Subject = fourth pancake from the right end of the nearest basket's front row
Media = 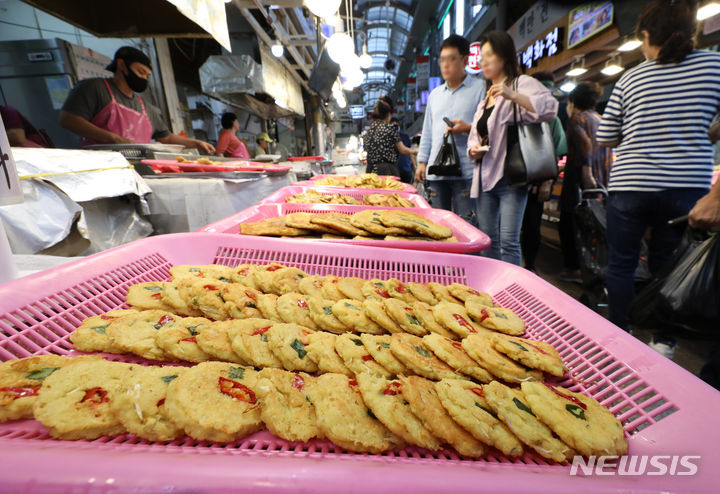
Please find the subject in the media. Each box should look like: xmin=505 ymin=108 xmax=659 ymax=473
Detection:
xmin=399 ymin=376 xmax=485 ymax=458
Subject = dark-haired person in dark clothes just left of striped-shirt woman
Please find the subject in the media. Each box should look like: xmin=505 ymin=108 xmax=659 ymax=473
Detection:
xmin=559 ymin=82 xmax=612 ymax=282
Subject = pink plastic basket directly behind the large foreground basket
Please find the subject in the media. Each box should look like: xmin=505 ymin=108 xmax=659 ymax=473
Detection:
xmin=197 ymin=203 xmax=491 ymax=253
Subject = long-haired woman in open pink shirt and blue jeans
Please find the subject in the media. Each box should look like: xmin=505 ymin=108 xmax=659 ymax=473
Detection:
xmin=468 ymin=31 xmax=558 ymax=265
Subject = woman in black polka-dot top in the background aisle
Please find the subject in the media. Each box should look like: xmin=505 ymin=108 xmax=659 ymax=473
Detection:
xmin=363 ymin=95 xmax=417 ymax=176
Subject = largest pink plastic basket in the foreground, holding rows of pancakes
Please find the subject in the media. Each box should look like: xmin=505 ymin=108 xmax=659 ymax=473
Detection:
xmin=0 ymin=234 xmax=720 ymax=494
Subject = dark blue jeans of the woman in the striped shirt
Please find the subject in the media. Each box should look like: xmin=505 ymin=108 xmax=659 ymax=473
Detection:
xmin=605 ymin=189 xmax=707 ymax=331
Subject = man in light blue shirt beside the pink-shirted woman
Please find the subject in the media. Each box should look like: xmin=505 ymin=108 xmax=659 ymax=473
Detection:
xmin=415 ymin=34 xmax=485 ymax=224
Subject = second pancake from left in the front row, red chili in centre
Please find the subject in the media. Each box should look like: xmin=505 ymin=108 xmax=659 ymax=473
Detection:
xmin=33 ymin=359 xmax=142 ymax=440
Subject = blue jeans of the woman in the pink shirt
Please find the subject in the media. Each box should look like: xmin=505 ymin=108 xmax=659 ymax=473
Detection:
xmin=477 ymin=178 xmax=528 ymax=266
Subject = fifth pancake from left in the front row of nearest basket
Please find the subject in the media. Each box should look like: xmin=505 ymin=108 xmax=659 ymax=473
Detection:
xmin=255 ymin=369 xmax=320 ymax=442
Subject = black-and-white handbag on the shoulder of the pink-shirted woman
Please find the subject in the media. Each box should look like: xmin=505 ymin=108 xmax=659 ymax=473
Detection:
xmin=505 ymin=80 xmax=558 ymax=187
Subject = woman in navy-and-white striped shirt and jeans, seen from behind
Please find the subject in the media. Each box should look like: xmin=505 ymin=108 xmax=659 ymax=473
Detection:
xmin=597 ymin=0 xmax=720 ymax=330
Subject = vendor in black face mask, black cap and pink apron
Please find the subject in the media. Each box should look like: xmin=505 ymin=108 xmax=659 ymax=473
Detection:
xmin=60 ymin=46 xmax=215 ymax=153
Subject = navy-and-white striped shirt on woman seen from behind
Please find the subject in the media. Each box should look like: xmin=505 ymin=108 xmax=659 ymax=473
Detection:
xmin=597 ymin=50 xmax=720 ymax=191
